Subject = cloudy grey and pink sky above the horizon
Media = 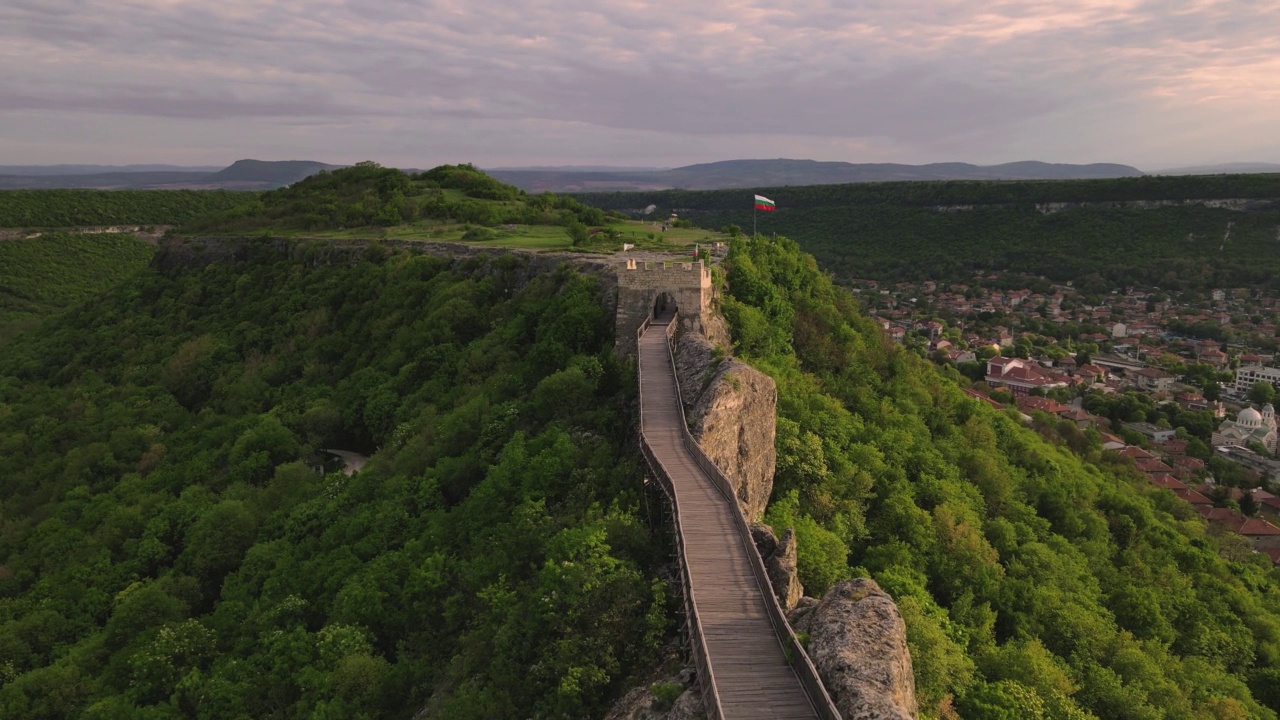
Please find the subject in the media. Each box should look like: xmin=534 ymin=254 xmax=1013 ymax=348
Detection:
xmin=0 ymin=0 xmax=1280 ymax=170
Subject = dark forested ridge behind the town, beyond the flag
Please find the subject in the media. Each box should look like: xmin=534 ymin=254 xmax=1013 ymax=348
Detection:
xmin=576 ymin=174 xmax=1280 ymax=290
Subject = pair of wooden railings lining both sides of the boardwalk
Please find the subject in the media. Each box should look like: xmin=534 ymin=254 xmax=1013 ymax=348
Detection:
xmin=636 ymin=314 xmax=842 ymax=720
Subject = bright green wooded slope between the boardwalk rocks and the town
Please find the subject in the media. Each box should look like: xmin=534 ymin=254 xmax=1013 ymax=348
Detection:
xmin=723 ymin=233 xmax=1280 ymax=720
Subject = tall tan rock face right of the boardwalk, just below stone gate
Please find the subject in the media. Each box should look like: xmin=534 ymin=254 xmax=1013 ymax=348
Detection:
xmin=676 ymin=320 xmax=778 ymax=521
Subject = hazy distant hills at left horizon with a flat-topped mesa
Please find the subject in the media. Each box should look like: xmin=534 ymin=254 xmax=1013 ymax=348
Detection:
xmin=0 ymin=160 xmax=342 ymax=190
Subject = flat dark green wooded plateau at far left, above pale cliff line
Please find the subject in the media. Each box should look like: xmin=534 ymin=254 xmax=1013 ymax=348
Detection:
xmin=0 ymin=190 xmax=256 ymax=228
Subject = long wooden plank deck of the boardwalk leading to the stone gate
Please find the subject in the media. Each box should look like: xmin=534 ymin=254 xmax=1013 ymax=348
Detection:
xmin=639 ymin=320 xmax=818 ymax=720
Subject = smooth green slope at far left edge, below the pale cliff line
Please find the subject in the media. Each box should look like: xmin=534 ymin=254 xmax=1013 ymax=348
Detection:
xmin=0 ymin=233 xmax=155 ymax=345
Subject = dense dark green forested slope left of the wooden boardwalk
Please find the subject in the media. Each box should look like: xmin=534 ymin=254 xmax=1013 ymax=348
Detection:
xmin=0 ymin=242 xmax=671 ymax=720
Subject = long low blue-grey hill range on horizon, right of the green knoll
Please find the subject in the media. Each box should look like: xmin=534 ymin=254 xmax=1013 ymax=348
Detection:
xmin=489 ymin=159 xmax=1143 ymax=192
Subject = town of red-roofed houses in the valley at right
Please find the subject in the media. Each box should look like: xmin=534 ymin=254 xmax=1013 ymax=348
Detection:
xmin=851 ymin=273 xmax=1280 ymax=565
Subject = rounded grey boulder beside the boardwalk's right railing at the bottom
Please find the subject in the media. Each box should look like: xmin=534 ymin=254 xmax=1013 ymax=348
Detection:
xmin=791 ymin=579 xmax=919 ymax=720
